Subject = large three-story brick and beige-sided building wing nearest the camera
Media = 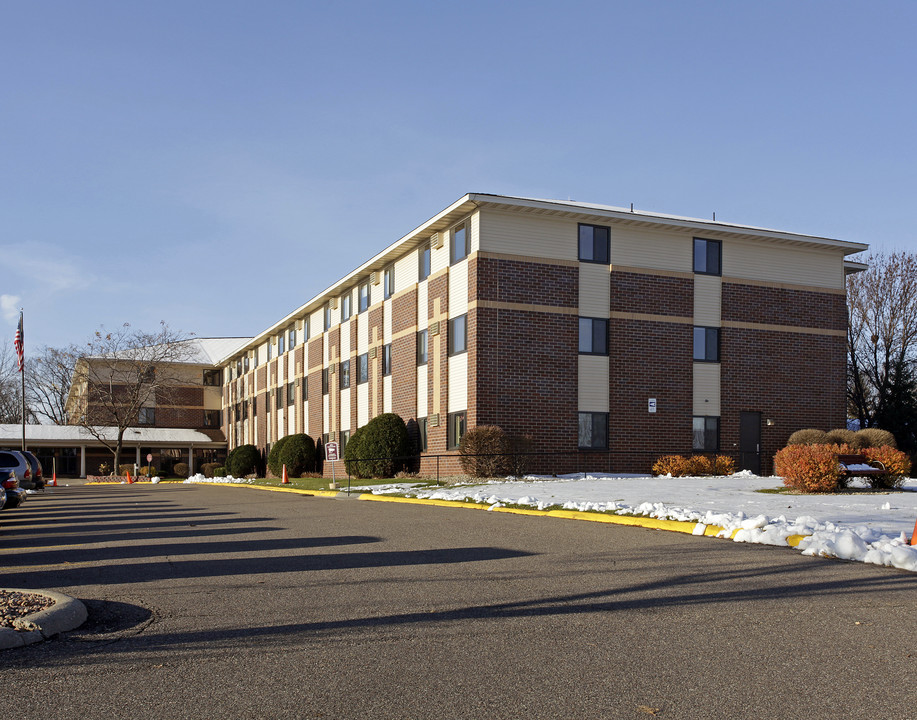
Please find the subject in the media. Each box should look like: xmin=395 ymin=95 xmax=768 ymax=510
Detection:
xmin=222 ymin=194 xmax=867 ymax=472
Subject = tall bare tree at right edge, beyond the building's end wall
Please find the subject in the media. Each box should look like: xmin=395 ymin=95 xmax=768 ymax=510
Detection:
xmin=847 ymin=252 xmax=917 ymax=449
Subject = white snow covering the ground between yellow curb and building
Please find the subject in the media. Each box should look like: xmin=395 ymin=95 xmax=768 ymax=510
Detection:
xmin=364 ymin=471 xmax=917 ymax=572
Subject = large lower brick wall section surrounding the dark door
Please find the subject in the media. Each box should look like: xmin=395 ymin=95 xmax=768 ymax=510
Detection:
xmin=720 ymin=328 xmax=846 ymax=473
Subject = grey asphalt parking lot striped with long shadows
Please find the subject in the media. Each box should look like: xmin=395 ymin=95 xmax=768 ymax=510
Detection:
xmin=0 ymin=484 xmax=917 ymax=720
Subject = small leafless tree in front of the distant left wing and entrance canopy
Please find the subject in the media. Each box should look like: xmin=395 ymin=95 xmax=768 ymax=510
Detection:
xmin=67 ymin=323 xmax=192 ymax=471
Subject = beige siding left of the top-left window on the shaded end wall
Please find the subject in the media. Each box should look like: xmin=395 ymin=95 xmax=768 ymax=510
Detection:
xmin=479 ymin=210 xmax=579 ymax=261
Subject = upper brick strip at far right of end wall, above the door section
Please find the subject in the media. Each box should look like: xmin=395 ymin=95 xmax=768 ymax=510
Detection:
xmin=722 ymin=282 xmax=847 ymax=332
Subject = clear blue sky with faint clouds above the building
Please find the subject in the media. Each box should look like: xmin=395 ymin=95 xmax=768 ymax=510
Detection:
xmin=0 ymin=0 xmax=917 ymax=351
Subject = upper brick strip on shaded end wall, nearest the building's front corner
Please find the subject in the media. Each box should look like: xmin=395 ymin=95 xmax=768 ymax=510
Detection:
xmin=476 ymin=258 xmax=579 ymax=307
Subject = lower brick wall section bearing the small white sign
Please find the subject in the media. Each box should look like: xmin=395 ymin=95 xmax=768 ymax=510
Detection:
xmin=608 ymin=319 xmax=694 ymax=472
